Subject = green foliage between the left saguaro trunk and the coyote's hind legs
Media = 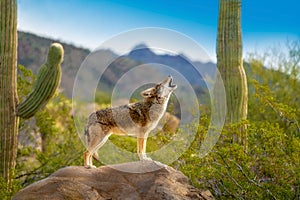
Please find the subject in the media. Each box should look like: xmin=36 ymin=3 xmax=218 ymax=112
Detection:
xmin=8 ymin=65 xmax=84 ymax=195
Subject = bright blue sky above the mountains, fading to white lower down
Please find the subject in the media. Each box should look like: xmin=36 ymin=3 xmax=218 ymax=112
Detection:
xmin=18 ymin=0 xmax=300 ymax=60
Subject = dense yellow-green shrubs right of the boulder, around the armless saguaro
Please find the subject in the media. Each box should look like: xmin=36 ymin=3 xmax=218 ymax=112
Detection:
xmin=173 ymin=42 xmax=300 ymax=199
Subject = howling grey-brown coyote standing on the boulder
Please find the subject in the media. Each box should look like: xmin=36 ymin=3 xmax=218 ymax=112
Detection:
xmin=84 ymin=76 xmax=177 ymax=167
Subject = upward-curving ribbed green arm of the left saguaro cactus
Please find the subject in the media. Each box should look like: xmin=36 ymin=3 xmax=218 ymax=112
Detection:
xmin=18 ymin=43 xmax=64 ymax=119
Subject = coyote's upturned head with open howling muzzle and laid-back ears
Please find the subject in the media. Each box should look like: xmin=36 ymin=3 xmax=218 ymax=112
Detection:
xmin=141 ymin=76 xmax=177 ymax=103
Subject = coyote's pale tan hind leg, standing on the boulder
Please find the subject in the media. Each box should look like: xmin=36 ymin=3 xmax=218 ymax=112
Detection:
xmin=84 ymin=124 xmax=110 ymax=168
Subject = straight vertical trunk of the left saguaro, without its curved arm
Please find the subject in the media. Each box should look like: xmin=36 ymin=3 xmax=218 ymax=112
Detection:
xmin=0 ymin=0 xmax=18 ymax=183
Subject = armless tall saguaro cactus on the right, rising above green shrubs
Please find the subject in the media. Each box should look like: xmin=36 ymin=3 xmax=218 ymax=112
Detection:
xmin=217 ymin=0 xmax=248 ymax=140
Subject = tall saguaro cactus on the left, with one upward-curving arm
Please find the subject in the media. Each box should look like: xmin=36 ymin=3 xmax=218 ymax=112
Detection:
xmin=0 ymin=0 xmax=64 ymax=189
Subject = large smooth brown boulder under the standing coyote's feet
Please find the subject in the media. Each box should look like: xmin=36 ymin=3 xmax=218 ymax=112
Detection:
xmin=13 ymin=161 xmax=214 ymax=200
